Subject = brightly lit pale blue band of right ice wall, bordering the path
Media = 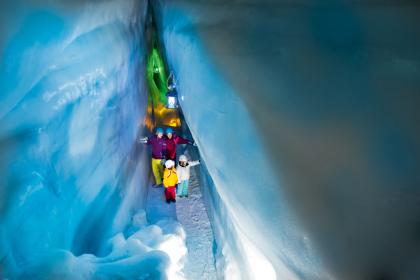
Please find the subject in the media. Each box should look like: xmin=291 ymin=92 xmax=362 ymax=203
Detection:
xmin=155 ymin=1 xmax=322 ymax=279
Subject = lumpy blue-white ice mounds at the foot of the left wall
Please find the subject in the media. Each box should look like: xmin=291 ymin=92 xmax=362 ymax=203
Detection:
xmin=17 ymin=212 xmax=187 ymax=280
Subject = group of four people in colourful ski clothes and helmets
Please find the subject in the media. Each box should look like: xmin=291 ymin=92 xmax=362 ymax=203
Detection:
xmin=140 ymin=127 xmax=200 ymax=203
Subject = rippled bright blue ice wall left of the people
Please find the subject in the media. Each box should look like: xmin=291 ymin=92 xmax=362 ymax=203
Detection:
xmin=0 ymin=0 xmax=149 ymax=275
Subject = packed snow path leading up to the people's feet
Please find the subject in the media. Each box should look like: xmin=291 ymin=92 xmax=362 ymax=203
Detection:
xmin=146 ymin=159 xmax=217 ymax=280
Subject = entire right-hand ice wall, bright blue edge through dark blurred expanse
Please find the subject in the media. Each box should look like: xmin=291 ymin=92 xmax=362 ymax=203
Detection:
xmin=155 ymin=0 xmax=420 ymax=279
